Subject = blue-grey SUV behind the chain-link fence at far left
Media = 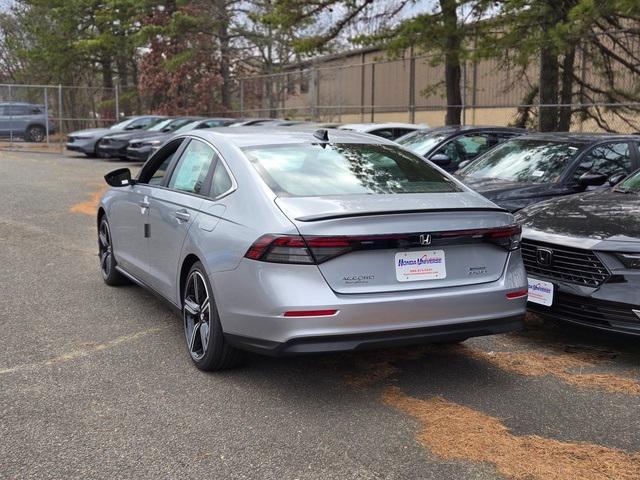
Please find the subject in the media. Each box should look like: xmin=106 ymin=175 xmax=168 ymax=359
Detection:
xmin=0 ymin=102 xmax=56 ymax=142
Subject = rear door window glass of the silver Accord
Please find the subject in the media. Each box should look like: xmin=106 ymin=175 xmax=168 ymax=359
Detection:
xmin=169 ymin=140 xmax=215 ymax=194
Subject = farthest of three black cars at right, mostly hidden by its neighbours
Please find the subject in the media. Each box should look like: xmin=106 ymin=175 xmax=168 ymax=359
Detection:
xmin=396 ymin=126 xmax=527 ymax=172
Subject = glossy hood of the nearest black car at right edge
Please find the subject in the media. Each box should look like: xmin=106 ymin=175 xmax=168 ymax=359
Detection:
xmin=517 ymin=189 xmax=640 ymax=242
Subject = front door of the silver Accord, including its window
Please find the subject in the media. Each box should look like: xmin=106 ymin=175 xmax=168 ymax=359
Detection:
xmin=108 ymin=138 xmax=184 ymax=285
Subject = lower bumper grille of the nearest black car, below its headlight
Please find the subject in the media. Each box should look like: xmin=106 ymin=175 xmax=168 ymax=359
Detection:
xmin=528 ymin=292 xmax=640 ymax=329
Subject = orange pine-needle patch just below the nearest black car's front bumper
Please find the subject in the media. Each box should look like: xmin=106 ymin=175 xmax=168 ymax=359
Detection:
xmin=460 ymin=346 xmax=640 ymax=395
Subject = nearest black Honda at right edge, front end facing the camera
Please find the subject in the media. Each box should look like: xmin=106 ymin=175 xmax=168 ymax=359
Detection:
xmin=516 ymin=170 xmax=640 ymax=336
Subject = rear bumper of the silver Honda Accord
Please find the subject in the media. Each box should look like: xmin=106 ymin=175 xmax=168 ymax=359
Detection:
xmin=210 ymin=254 xmax=527 ymax=354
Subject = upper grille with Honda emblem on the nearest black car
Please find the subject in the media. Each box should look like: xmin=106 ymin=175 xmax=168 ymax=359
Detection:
xmin=522 ymin=240 xmax=609 ymax=287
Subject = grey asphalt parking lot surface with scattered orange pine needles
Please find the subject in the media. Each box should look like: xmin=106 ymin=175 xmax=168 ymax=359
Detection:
xmin=0 ymin=151 xmax=640 ymax=480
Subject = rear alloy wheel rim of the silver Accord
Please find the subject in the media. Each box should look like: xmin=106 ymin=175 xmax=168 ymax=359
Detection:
xmin=183 ymin=270 xmax=211 ymax=361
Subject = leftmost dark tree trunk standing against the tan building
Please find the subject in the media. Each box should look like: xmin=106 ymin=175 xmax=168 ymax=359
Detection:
xmin=440 ymin=0 xmax=462 ymax=125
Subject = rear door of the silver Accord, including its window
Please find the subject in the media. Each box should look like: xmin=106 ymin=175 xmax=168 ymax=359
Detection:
xmin=149 ymin=138 xmax=217 ymax=300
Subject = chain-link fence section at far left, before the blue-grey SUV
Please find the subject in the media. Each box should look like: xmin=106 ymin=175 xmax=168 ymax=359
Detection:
xmin=0 ymin=84 xmax=120 ymax=151
